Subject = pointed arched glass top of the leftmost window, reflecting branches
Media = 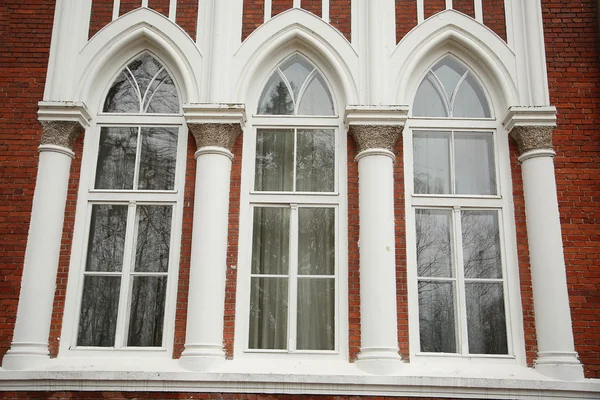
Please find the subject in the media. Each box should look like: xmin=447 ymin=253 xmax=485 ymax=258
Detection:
xmin=102 ymin=52 xmax=179 ymax=114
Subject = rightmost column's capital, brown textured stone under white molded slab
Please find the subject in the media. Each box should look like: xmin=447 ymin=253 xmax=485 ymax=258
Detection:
xmin=503 ymin=106 xmax=556 ymax=155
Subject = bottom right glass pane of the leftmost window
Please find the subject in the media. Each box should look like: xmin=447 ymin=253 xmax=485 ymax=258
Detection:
xmin=127 ymin=276 xmax=167 ymax=347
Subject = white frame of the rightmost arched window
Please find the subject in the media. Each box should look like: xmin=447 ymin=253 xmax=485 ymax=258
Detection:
xmin=403 ymin=54 xmax=526 ymax=365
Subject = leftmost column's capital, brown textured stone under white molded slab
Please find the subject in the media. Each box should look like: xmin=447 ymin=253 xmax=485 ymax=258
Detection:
xmin=38 ymin=101 xmax=91 ymax=150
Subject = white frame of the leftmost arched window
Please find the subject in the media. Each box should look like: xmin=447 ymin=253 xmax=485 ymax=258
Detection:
xmin=59 ymin=50 xmax=188 ymax=359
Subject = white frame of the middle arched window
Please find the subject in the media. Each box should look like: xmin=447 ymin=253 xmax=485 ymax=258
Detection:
xmin=234 ymin=52 xmax=348 ymax=361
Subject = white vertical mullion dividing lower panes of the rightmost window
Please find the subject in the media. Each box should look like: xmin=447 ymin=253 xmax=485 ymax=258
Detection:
xmin=453 ymin=206 xmax=469 ymax=354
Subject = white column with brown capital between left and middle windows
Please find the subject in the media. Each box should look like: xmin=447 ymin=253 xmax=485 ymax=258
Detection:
xmin=180 ymin=123 xmax=241 ymax=371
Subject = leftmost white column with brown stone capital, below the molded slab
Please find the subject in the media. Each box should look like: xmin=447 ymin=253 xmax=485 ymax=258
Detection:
xmin=2 ymin=121 xmax=82 ymax=369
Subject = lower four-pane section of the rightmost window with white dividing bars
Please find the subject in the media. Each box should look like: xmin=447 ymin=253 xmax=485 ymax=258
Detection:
xmin=416 ymin=207 xmax=510 ymax=355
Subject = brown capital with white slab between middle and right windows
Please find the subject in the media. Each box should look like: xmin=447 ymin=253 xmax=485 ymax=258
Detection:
xmin=345 ymin=105 xmax=408 ymax=153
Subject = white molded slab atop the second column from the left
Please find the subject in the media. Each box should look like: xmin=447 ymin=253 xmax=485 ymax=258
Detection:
xmin=183 ymin=103 xmax=246 ymax=128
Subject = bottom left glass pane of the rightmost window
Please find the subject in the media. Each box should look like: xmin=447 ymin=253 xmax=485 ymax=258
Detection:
xmin=419 ymin=282 xmax=457 ymax=353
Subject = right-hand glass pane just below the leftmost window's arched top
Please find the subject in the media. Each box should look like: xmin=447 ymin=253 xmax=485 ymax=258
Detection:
xmin=138 ymin=127 xmax=178 ymax=190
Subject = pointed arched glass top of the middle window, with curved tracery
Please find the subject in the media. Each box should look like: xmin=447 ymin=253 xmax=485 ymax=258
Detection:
xmin=258 ymin=55 xmax=335 ymax=115
